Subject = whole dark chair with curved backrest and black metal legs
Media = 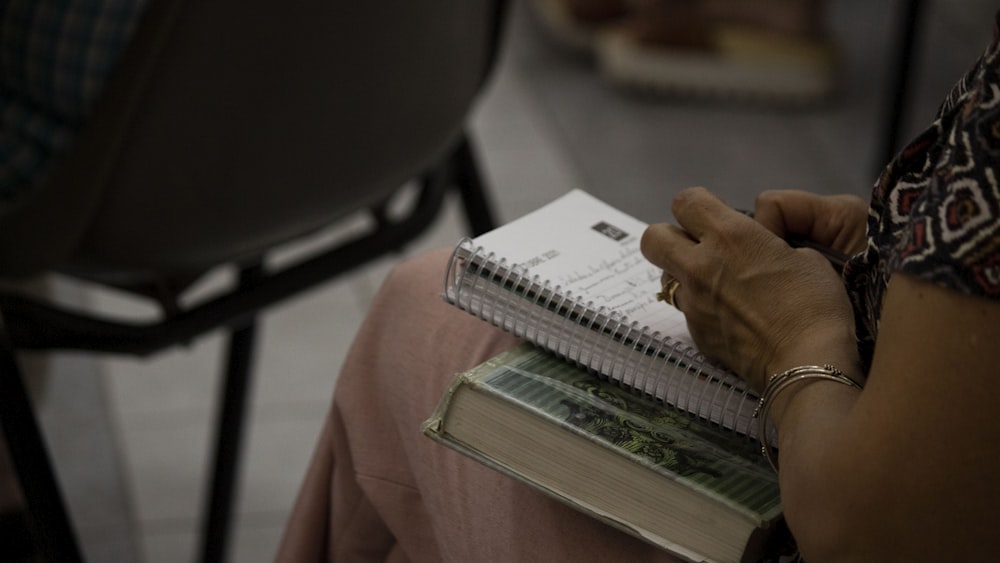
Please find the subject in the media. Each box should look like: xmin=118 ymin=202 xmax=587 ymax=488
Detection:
xmin=0 ymin=0 xmax=506 ymax=562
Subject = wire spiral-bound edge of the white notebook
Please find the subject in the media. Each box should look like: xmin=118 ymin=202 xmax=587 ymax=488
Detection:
xmin=444 ymin=239 xmax=757 ymax=437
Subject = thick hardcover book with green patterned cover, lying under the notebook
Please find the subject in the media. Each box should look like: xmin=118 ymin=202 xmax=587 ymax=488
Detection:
xmin=424 ymin=344 xmax=781 ymax=561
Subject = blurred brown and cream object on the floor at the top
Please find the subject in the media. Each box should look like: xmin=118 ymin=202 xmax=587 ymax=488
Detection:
xmin=534 ymin=0 xmax=838 ymax=104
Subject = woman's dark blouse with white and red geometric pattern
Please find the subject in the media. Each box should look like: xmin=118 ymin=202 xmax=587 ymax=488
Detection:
xmin=844 ymin=14 xmax=1000 ymax=365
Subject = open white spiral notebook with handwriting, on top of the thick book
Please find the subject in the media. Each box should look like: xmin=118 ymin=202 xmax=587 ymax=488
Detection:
xmin=444 ymin=190 xmax=758 ymax=437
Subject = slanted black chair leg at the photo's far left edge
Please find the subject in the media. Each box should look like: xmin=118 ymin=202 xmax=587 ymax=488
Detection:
xmin=0 ymin=330 xmax=83 ymax=563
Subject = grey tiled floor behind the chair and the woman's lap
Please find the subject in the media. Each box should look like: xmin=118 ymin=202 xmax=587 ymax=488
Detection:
xmin=27 ymin=0 xmax=992 ymax=563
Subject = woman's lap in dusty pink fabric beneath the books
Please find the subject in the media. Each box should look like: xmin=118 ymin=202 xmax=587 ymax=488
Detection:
xmin=278 ymin=252 xmax=673 ymax=561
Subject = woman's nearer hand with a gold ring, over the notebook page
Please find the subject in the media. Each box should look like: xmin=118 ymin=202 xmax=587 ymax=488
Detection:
xmin=642 ymin=188 xmax=863 ymax=389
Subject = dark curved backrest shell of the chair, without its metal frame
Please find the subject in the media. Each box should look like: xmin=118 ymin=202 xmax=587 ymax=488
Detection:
xmin=0 ymin=0 xmax=499 ymax=284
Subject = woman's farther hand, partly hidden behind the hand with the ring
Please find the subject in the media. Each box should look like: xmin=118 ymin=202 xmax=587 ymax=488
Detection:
xmin=754 ymin=190 xmax=868 ymax=255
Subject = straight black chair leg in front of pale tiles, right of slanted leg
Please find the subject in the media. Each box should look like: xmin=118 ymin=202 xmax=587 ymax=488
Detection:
xmin=201 ymin=264 xmax=262 ymax=563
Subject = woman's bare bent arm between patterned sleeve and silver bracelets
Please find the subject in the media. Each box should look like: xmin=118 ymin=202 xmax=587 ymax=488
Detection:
xmin=760 ymin=275 xmax=1000 ymax=562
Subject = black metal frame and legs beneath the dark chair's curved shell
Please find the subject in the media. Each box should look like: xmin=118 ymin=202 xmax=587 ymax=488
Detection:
xmin=0 ymin=131 xmax=495 ymax=562
